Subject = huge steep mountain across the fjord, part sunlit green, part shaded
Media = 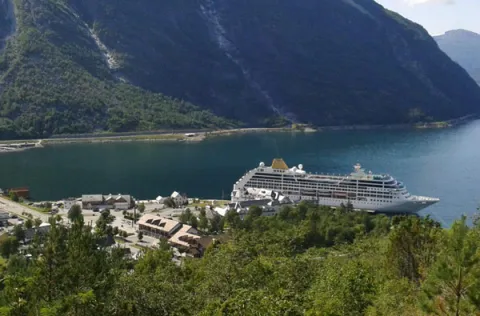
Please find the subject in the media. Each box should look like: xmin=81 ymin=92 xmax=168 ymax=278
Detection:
xmin=0 ymin=0 xmax=480 ymax=138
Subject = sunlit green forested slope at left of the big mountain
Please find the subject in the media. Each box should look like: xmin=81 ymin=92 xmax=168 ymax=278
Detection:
xmin=0 ymin=0 xmax=232 ymax=138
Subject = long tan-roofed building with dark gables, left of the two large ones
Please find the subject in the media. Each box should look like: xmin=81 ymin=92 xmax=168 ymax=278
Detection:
xmin=138 ymin=214 xmax=182 ymax=238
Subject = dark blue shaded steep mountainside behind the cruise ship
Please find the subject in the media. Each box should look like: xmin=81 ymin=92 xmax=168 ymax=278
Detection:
xmin=69 ymin=0 xmax=480 ymax=125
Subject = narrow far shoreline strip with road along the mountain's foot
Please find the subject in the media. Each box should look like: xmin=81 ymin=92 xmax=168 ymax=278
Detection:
xmin=0 ymin=114 xmax=478 ymax=154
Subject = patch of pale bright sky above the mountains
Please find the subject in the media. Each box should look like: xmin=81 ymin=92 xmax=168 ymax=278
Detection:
xmin=376 ymin=0 xmax=480 ymax=35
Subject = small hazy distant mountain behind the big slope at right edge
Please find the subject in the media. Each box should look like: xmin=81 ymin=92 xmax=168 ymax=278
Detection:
xmin=435 ymin=30 xmax=480 ymax=85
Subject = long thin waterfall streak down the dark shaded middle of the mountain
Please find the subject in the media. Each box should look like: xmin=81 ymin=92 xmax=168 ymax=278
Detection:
xmin=200 ymin=0 xmax=294 ymax=121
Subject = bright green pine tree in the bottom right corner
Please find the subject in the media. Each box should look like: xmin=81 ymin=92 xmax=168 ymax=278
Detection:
xmin=422 ymin=216 xmax=480 ymax=316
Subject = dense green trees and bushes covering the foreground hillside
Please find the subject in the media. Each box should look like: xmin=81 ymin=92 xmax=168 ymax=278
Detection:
xmin=0 ymin=204 xmax=480 ymax=316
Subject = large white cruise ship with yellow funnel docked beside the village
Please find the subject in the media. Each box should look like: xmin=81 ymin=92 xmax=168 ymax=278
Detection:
xmin=231 ymin=159 xmax=439 ymax=213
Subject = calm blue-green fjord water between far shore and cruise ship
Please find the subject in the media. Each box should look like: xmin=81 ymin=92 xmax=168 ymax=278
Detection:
xmin=0 ymin=121 xmax=480 ymax=225
